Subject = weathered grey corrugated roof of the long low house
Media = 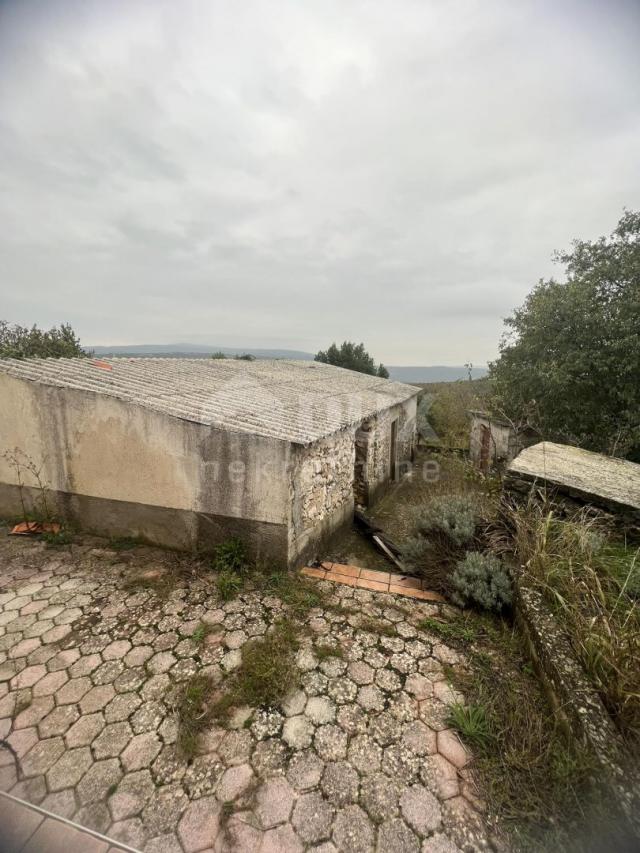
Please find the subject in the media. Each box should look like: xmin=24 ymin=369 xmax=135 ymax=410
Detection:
xmin=0 ymin=358 xmax=420 ymax=444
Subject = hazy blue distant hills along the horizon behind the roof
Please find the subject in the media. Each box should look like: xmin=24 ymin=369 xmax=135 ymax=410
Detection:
xmin=87 ymin=343 xmax=487 ymax=382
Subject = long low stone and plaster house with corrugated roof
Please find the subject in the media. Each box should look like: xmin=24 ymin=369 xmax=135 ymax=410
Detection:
xmin=0 ymin=358 xmax=419 ymax=565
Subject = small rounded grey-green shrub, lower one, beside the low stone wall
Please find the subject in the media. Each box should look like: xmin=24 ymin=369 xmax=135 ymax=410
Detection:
xmin=451 ymin=551 xmax=512 ymax=613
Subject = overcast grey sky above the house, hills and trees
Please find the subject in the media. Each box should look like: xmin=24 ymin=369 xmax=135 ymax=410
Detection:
xmin=0 ymin=0 xmax=640 ymax=364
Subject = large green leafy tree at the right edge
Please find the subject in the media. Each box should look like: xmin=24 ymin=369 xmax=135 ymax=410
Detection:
xmin=490 ymin=211 xmax=640 ymax=459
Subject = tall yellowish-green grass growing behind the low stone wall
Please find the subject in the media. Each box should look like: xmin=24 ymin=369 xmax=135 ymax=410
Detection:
xmin=509 ymin=502 xmax=640 ymax=751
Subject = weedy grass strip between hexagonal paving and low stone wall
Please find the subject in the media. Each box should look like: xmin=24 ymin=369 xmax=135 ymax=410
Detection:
xmin=438 ymin=612 xmax=606 ymax=851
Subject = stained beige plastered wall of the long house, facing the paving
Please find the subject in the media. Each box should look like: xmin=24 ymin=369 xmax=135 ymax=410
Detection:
xmin=0 ymin=374 xmax=289 ymax=560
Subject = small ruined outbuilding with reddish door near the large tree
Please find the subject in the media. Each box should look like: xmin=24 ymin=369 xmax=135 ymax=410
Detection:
xmin=469 ymin=411 xmax=540 ymax=474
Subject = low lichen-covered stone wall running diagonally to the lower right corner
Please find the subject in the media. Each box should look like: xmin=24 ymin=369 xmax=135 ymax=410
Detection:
xmin=515 ymin=576 xmax=640 ymax=838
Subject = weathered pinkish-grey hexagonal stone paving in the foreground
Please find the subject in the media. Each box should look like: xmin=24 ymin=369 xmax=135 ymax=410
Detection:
xmin=0 ymin=528 xmax=490 ymax=853
